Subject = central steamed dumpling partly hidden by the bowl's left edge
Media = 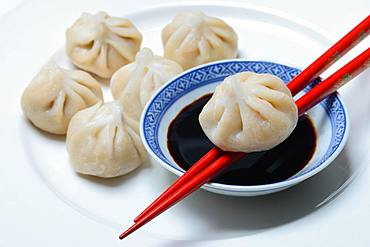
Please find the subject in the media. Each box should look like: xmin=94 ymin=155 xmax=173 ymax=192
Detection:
xmin=111 ymin=48 xmax=182 ymax=121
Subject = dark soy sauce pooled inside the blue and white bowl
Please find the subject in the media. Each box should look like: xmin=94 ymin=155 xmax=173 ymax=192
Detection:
xmin=167 ymin=94 xmax=316 ymax=185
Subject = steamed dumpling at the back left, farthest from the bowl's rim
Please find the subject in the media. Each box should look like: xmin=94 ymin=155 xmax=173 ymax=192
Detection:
xmin=66 ymin=12 xmax=142 ymax=78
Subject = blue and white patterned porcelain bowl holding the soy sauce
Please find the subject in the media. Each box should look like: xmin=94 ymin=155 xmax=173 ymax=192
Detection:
xmin=140 ymin=59 xmax=349 ymax=196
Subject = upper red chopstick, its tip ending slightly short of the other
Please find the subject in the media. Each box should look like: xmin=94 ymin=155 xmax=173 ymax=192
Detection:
xmin=134 ymin=15 xmax=370 ymax=226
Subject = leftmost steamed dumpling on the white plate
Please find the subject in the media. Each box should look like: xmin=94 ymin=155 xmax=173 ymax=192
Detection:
xmin=21 ymin=62 xmax=103 ymax=134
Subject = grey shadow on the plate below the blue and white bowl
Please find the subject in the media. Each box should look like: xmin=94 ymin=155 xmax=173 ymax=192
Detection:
xmin=172 ymin=149 xmax=356 ymax=240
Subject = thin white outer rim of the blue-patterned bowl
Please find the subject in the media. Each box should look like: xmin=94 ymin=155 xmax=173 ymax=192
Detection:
xmin=140 ymin=58 xmax=350 ymax=192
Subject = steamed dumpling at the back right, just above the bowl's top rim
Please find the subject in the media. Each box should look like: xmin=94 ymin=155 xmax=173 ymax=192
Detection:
xmin=162 ymin=11 xmax=238 ymax=69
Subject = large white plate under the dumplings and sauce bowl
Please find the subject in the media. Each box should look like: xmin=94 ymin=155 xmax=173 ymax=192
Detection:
xmin=0 ymin=1 xmax=370 ymax=246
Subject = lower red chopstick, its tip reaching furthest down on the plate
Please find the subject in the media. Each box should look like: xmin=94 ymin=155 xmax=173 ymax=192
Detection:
xmin=119 ymin=48 xmax=370 ymax=239
